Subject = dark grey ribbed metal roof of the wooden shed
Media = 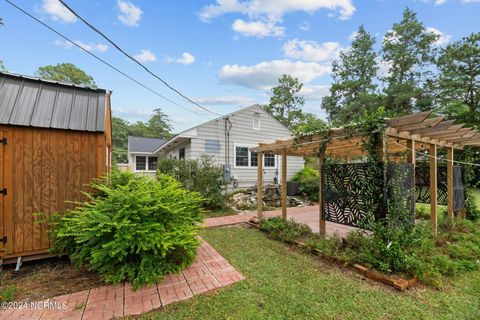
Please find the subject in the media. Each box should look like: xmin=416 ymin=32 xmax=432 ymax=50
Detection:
xmin=0 ymin=72 xmax=107 ymax=132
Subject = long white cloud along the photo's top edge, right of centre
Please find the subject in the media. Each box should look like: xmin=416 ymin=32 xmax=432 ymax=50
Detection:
xmin=200 ymin=0 xmax=356 ymax=21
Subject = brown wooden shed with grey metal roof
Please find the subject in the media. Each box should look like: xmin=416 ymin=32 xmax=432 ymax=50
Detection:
xmin=0 ymin=72 xmax=112 ymax=263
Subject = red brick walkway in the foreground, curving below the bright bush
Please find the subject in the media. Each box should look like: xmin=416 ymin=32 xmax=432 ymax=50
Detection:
xmin=0 ymin=241 xmax=245 ymax=320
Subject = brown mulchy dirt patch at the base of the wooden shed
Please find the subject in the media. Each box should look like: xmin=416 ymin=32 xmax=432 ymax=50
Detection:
xmin=0 ymin=258 xmax=103 ymax=301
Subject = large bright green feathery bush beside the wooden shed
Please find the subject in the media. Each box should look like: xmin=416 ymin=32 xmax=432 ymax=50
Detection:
xmin=50 ymin=172 xmax=203 ymax=288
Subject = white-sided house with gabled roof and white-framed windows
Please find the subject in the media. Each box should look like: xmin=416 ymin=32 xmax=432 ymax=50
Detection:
xmin=128 ymin=104 xmax=304 ymax=189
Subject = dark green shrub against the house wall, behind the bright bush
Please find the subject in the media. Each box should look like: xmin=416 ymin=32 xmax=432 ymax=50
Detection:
xmin=158 ymin=156 xmax=226 ymax=210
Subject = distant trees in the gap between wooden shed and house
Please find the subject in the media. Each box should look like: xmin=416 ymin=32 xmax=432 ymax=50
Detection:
xmin=112 ymin=108 xmax=173 ymax=163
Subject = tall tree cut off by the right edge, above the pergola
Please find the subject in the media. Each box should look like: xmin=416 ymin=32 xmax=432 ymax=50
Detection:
xmin=437 ymin=33 xmax=480 ymax=127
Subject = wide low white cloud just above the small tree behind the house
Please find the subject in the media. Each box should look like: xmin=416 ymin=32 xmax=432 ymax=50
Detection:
xmin=218 ymin=59 xmax=331 ymax=90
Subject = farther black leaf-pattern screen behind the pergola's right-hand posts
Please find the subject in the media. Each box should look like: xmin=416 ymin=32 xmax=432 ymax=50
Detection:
xmin=415 ymin=163 xmax=465 ymax=211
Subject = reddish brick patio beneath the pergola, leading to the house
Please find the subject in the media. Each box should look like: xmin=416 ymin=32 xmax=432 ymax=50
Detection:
xmin=204 ymin=205 xmax=355 ymax=237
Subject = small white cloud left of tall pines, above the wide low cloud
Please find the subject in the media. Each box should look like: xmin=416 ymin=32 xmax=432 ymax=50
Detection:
xmin=283 ymin=39 xmax=342 ymax=62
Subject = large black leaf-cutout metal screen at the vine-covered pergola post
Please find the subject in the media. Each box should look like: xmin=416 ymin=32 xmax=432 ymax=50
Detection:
xmin=322 ymin=163 xmax=414 ymax=228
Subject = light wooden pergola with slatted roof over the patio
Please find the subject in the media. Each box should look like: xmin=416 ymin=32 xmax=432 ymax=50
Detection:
xmin=255 ymin=111 xmax=480 ymax=236
